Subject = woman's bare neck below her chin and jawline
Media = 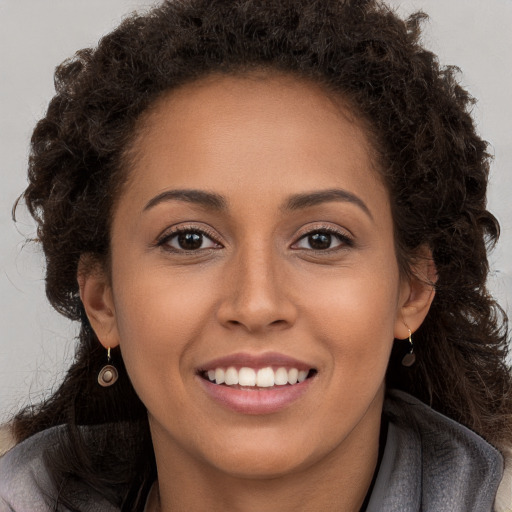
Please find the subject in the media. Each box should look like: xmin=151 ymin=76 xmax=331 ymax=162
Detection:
xmin=148 ymin=398 xmax=382 ymax=512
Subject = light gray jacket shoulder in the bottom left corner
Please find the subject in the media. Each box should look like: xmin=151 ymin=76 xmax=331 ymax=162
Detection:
xmin=0 ymin=428 xmax=57 ymax=512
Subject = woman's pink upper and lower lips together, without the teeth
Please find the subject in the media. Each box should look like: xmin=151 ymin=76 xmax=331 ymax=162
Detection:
xmin=196 ymin=352 xmax=315 ymax=415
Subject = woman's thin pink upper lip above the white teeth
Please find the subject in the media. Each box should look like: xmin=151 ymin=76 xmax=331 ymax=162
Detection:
xmin=198 ymin=352 xmax=315 ymax=372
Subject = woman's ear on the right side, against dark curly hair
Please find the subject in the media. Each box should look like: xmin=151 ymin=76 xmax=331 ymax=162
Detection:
xmin=395 ymin=247 xmax=437 ymax=339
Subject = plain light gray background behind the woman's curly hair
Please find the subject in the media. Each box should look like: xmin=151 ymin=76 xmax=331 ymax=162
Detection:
xmin=0 ymin=0 xmax=512 ymax=422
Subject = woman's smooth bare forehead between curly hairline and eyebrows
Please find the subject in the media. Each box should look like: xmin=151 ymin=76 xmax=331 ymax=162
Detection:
xmin=119 ymin=72 xmax=382 ymax=212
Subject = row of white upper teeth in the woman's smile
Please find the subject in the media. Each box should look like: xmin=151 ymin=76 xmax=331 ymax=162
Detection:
xmin=207 ymin=366 xmax=309 ymax=388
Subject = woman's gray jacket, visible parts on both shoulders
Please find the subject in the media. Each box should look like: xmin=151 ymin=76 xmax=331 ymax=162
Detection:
xmin=0 ymin=391 xmax=503 ymax=512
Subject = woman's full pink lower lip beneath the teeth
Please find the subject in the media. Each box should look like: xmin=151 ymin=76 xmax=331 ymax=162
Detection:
xmin=197 ymin=376 xmax=314 ymax=414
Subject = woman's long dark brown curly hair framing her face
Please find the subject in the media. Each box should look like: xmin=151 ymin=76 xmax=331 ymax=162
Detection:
xmin=15 ymin=0 xmax=512 ymax=510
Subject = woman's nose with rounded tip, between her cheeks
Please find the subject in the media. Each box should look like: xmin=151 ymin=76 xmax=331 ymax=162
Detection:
xmin=217 ymin=245 xmax=297 ymax=334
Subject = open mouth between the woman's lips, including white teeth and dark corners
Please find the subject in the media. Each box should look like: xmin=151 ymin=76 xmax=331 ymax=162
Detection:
xmin=199 ymin=366 xmax=317 ymax=391
